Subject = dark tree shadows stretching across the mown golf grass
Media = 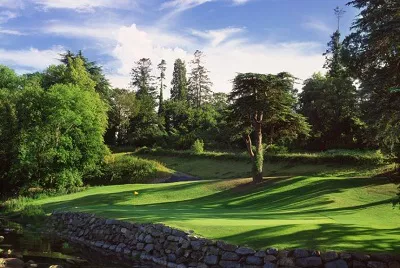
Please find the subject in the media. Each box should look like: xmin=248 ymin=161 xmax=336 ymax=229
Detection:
xmin=39 ymin=177 xmax=400 ymax=251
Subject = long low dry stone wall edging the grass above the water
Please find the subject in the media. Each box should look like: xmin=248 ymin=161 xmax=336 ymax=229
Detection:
xmin=48 ymin=212 xmax=400 ymax=268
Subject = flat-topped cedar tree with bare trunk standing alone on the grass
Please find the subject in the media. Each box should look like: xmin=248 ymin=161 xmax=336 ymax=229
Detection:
xmin=229 ymin=73 xmax=308 ymax=183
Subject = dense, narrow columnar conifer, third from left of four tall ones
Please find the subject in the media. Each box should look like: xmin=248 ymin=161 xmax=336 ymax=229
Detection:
xmin=171 ymin=59 xmax=188 ymax=101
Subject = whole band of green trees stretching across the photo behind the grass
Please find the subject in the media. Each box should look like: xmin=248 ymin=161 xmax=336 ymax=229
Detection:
xmin=0 ymin=0 xmax=400 ymax=195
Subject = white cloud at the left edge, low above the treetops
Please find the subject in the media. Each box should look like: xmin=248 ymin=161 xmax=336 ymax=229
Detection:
xmin=0 ymin=46 xmax=64 ymax=70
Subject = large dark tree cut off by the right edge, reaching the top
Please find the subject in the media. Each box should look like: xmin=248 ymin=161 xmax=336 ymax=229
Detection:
xmin=344 ymin=0 xmax=400 ymax=162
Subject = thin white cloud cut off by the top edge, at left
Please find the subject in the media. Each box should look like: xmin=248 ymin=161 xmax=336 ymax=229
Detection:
xmin=33 ymin=0 xmax=136 ymax=12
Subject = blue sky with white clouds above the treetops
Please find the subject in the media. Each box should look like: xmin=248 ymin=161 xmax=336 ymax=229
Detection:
xmin=0 ymin=0 xmax=358 ymax=96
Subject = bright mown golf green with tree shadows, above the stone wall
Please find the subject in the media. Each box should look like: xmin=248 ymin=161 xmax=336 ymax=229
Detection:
xmin=33 ymin=173 xmax=400 ymax=252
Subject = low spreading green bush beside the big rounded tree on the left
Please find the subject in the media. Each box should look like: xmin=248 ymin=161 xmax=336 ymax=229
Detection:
xmin=88 ymin=154 xmax=171 ymax=185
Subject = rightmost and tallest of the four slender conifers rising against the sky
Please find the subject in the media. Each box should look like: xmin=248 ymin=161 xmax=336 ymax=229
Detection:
xmin=188 ymin=50 xmax=212 ymax=107
